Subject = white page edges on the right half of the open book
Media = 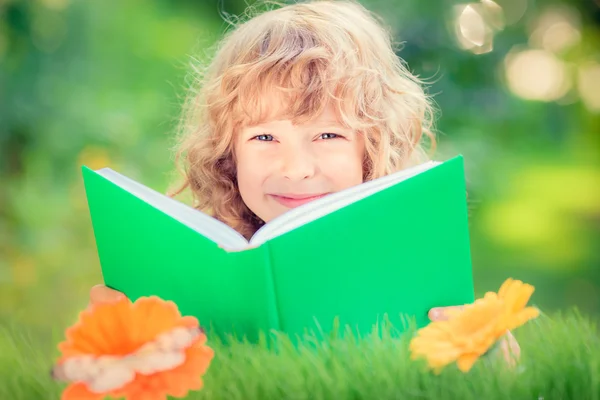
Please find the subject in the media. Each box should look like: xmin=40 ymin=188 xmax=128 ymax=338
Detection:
xmin=250 ymin=161 xmax=441 ymax=245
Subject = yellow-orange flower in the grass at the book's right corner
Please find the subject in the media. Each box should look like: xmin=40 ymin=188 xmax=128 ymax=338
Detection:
xmin=410 ymin=279 xmax=539 ymax=373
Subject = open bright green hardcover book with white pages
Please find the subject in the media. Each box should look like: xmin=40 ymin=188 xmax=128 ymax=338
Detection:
xmin=82 ymin=156 xmax=474 ymax=340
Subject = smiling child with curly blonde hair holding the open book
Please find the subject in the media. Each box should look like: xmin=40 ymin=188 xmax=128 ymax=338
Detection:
xmin=85 ymin=1 xmax=517 ymax=362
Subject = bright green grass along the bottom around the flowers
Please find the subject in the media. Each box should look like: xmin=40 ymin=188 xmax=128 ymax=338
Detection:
xmin=0 ymin=311 xmax=600 ymax=400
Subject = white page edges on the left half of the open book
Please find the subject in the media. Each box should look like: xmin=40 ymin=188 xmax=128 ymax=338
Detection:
xmin=96 ymin=168 xmax=248 ymax=249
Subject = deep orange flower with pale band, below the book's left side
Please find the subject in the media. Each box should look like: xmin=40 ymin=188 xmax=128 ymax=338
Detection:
xmin=52 ymin=296 xmax=214 ymax=400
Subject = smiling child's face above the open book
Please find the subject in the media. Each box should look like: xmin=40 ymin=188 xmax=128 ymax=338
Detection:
xmin=235 ymin=102 xmax=365 ymax=222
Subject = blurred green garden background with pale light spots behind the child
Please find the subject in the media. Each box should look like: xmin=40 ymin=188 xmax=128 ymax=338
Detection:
xmin=0 ymin=0 xmax=600 ymax=338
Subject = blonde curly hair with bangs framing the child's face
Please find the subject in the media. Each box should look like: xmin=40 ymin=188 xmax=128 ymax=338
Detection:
xmin=170 ymin=1 xmax=435 ymax=238
